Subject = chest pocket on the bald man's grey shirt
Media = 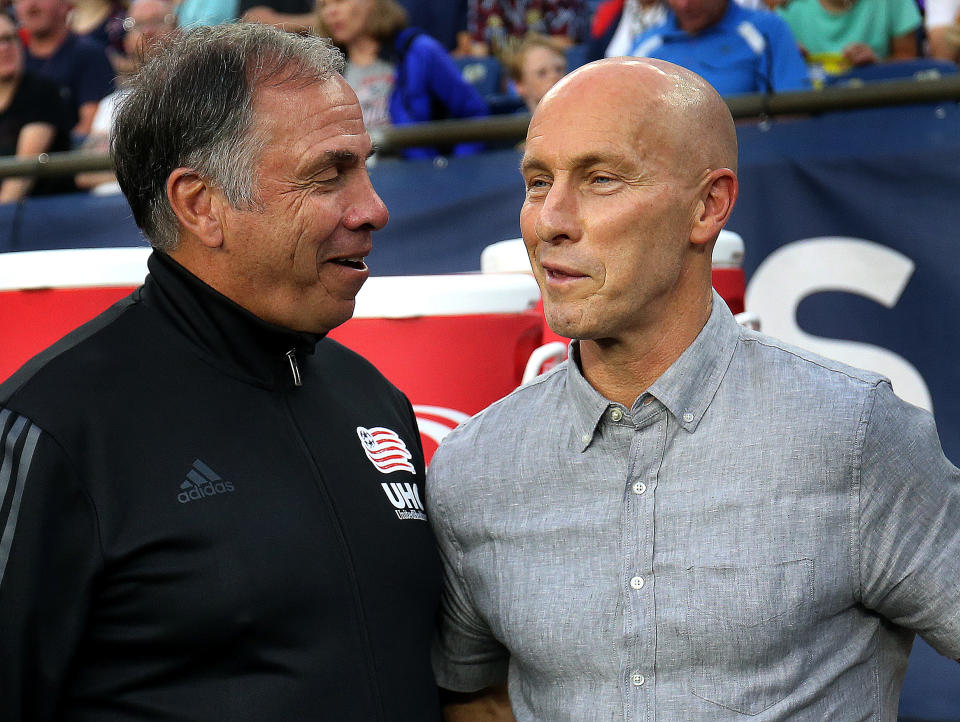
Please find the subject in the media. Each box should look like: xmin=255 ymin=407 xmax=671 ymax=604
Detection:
xmin=686 ymin=559 xmax=814 ymax=715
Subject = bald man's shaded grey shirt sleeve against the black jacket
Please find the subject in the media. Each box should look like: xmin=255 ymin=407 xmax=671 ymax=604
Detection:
xmin=426 ymin=436 xmax=509 ymax=692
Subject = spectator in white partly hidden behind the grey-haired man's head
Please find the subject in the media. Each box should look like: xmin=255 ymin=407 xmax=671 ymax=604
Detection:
xmin=76 ymin=0 xmax=177 ymax=193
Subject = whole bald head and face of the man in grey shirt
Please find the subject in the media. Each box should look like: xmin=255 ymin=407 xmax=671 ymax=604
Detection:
xmin=520 ymin=58 xmax=738 ymax=350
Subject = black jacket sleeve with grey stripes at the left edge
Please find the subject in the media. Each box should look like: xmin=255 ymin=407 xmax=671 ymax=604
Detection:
xmin=0 ymin=409 xmax=102 ymax=722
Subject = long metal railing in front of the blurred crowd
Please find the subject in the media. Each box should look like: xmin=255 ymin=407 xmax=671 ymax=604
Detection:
xmin=0 ymin=75 xmax=960 ymax=178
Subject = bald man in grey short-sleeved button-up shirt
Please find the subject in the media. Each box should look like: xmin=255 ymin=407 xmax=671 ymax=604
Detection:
xmin=427 ymin=58 xmax=960 ymax=722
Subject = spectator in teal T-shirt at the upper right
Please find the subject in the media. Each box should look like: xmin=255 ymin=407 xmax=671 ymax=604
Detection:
xmin=777 ymin=0 xmax=920 ymax=75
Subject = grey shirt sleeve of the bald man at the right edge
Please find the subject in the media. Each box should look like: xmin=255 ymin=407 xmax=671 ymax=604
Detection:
xmin=859 ymin=382 xmax=960 ymax=659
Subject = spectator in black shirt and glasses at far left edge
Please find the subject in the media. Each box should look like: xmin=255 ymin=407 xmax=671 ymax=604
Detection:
xmin=0 ymin=13 xmax=72 ymax=203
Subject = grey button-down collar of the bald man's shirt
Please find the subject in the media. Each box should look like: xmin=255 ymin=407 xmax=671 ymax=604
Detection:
xmin=567 ymin=291 xmax=740 ymax=451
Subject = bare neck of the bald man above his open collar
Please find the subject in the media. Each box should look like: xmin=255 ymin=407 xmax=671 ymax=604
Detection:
xmin=580 ymin=295 xmax=712 ymax=408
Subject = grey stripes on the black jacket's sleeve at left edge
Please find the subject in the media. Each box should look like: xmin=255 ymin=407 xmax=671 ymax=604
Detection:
xmin=0 ymin=409 xmax=40 ymax=584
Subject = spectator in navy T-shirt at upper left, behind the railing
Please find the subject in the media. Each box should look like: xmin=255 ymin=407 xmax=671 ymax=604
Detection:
xmin=14 ymin=0 xmax=113 ymax=136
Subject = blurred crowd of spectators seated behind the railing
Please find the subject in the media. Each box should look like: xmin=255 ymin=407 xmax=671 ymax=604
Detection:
xmin=0 ymin=0 xmax=960 ymax=203
